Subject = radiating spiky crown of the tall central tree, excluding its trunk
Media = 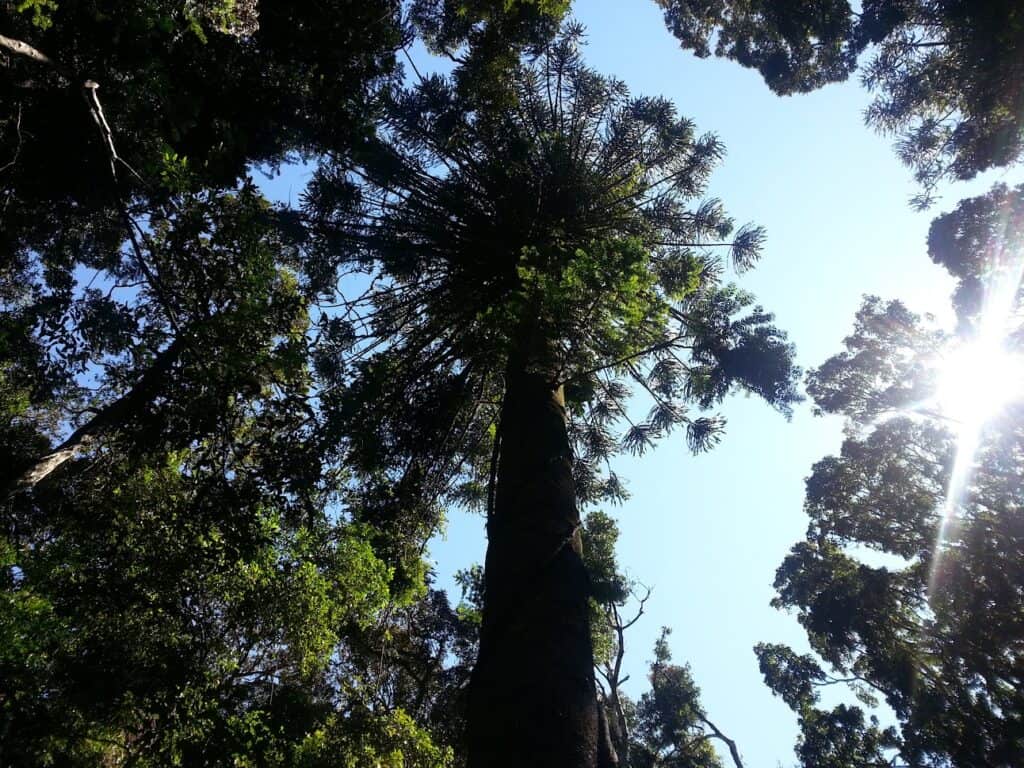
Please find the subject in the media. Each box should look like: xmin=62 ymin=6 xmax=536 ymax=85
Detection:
xmin=305 ymin=24 xmax=797 ymax=514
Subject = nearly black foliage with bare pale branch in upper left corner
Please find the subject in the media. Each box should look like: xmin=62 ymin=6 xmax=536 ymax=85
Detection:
xmin=0 ymin=0 xmax=403 ymax=256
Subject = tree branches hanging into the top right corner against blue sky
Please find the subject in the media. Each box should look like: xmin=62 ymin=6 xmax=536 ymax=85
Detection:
xmin=656 ymin=0 xmax=1024 ymax=205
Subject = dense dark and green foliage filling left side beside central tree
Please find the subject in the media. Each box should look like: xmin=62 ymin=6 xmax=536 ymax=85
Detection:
xmin=0 ymin=2 xmax=450 ymax=766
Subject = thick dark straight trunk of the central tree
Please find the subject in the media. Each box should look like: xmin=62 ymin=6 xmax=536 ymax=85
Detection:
xmin=468 ymin=333 xmax=599 ymax=768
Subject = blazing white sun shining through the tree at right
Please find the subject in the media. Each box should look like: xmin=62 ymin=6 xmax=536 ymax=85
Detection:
xmin=935 ymin=341 xmax=1024 ymax=432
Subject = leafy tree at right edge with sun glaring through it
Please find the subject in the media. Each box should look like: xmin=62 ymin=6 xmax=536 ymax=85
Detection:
xmin=758 ymin=187 xmax=1024 ymax=768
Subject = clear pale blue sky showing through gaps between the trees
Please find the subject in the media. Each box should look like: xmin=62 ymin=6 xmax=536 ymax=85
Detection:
xmin=253 ymin=0 xmax=1021 ymax=768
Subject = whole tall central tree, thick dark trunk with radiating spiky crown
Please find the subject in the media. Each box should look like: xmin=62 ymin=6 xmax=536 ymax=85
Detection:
xmin=305 ymin=28 xmax=797 ymax=766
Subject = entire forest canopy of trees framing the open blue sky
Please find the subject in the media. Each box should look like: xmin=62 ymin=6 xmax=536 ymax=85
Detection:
xmin=0 ymin=0 xmax=1024 ymax=768
